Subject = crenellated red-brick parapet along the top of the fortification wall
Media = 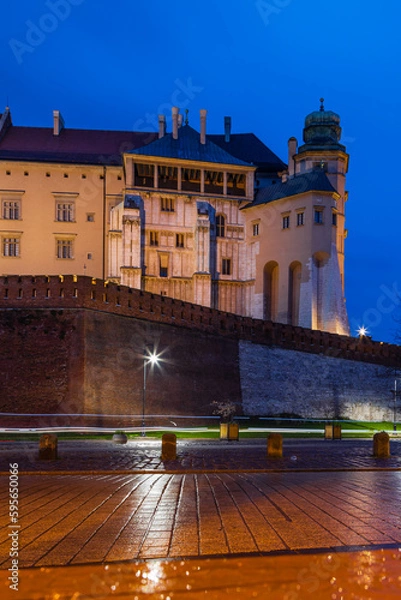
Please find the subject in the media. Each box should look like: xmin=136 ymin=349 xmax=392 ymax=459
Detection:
xmin=0 ymin=275 xmax=401 ymax=367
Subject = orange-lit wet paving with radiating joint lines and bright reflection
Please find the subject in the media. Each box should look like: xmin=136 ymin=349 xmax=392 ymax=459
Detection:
xmin=0 ymin=471 xmax=401 ymax=569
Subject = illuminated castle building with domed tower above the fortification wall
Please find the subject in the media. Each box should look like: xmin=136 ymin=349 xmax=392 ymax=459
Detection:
xmin=0 ymin=101 xmax=348 ymax=334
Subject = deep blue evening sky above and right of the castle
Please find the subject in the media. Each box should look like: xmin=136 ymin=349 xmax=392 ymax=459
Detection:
xmin=0 ymin=0 xmax=401 ymax=342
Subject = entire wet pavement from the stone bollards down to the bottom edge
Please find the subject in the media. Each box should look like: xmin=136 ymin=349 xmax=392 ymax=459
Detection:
xmin=0 ymin=439 xmax=401 ymax=600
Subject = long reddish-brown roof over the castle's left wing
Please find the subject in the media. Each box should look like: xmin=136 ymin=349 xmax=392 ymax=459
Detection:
xmin=0 ymin=125 xmax=158 ymax=165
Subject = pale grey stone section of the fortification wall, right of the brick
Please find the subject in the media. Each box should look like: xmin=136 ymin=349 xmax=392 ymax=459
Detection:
xmin=239 ymin=341 xmax=394 ymax=421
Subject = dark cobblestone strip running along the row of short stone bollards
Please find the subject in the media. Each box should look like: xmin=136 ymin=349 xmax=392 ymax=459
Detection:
xmin=0 ymin=438 xmax=401 ymax=473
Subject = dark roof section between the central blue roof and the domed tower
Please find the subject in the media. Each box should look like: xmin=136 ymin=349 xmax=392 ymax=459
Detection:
xmin=208 ymin=133 xmax=287 ymax=173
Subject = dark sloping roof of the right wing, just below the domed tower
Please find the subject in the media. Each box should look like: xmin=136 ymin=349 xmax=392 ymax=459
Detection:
xmin=244 ymin=169 xmax=336 ymax=208
